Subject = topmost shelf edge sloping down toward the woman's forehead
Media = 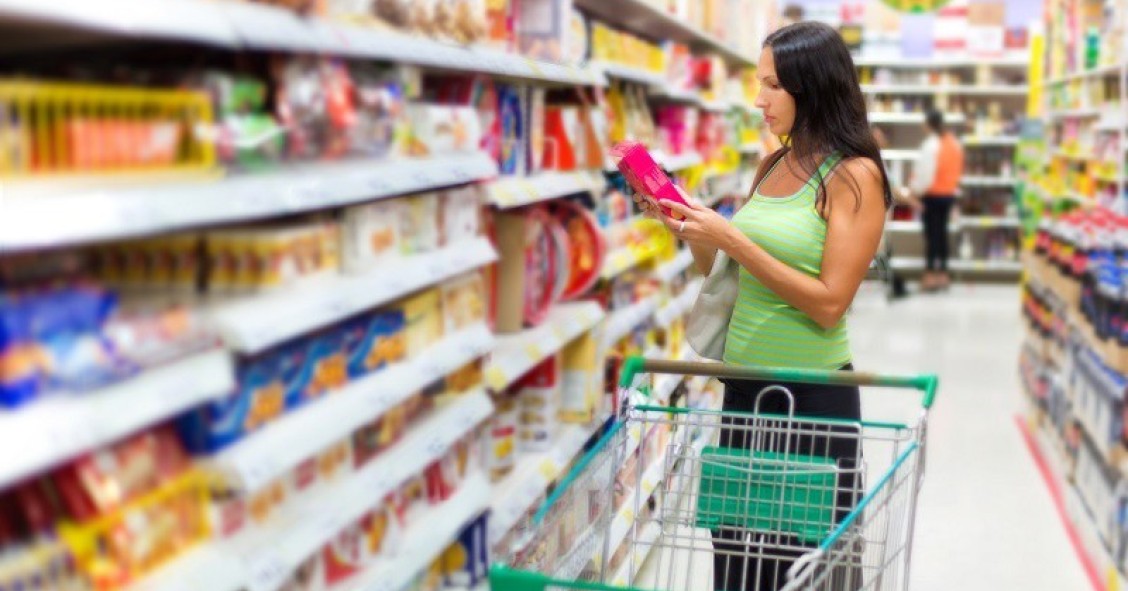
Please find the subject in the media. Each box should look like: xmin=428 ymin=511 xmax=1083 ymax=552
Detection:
xmin=575 ymin=0 xmax=756 ymax=67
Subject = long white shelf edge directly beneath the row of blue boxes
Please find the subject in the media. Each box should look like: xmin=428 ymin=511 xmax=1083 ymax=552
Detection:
xmin=212 ymin=325 xmax=494 ymax=492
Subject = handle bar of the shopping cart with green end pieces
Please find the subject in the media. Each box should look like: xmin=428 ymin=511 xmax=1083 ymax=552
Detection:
xmin=619 ymin=356 xmax=940 ymax=408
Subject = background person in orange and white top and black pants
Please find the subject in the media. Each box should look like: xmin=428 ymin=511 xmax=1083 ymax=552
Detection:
xmin=902 ymin=111 xmax=963 ymax=291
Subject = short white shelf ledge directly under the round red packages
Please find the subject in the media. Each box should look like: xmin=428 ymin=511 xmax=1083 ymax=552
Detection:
xmin=485 ymin=301 xmax=606 ymax=391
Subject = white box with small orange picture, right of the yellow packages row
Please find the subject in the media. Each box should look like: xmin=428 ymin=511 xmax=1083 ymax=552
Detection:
xmin=341 ymin=200 xmax=409 ymax=273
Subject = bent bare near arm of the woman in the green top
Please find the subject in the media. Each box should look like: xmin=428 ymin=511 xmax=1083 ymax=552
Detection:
xmin=667 ymin=158 xmax=885 ymax=329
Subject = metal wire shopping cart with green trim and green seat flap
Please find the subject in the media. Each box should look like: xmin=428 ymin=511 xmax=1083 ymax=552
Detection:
xmin=491 ymin=358 xmax=937 ymax=591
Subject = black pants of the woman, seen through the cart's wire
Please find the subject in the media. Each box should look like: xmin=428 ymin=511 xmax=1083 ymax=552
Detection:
xmin=712 ymin=364 xmax=863 ymax=591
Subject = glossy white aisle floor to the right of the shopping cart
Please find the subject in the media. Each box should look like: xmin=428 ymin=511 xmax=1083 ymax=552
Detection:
xmin=851 ymin=286 xmax=1091 ymax=591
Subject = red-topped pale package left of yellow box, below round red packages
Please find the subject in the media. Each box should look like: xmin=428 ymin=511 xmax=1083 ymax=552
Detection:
xmin=515 ymin=355 xmax=561 ymax=452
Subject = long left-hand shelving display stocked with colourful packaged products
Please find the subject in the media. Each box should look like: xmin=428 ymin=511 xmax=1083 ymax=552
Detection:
xmin=0 ymin=0 xmax=767 ymax=591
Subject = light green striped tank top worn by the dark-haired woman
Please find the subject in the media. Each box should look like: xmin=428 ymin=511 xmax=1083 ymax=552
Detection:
xmin=724 ymin=156 xmax=851 ymax=370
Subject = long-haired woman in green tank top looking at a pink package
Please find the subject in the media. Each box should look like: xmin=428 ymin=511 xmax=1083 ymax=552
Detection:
xmin=640 ymin=23 xmax=892 ymax=591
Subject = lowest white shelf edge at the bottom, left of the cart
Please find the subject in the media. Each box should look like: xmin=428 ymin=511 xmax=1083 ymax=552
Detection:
xmin=341 ymin=476 xmax=492 ymax=591
